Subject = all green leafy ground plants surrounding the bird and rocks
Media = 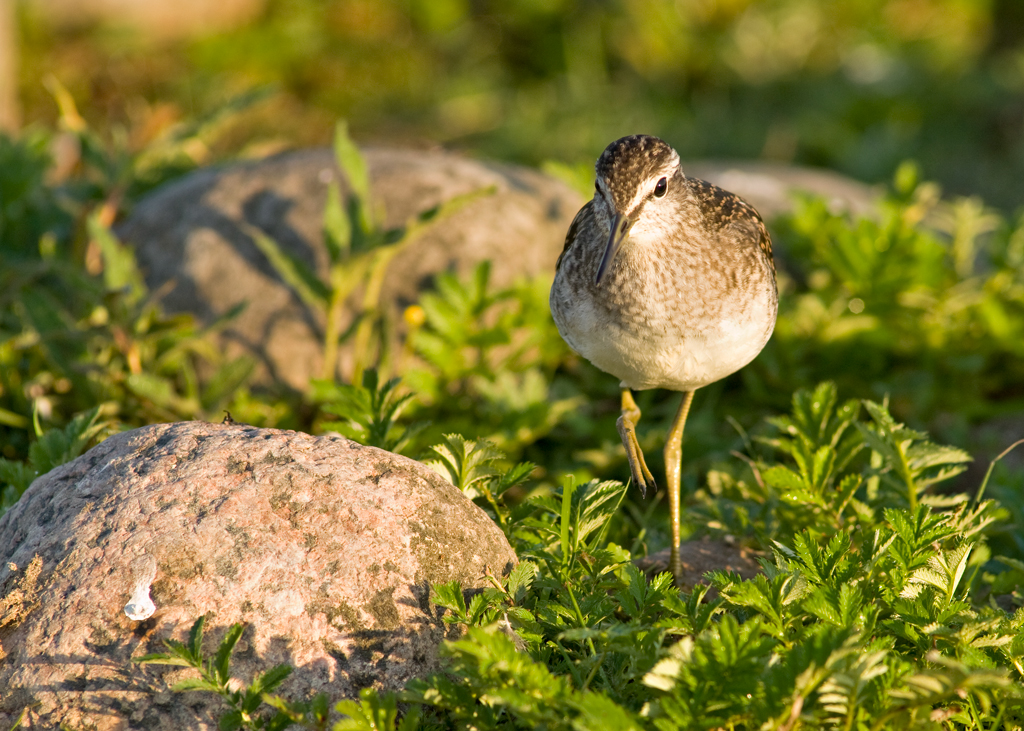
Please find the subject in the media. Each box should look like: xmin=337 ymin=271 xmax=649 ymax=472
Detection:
xmin=6 ymin=61 xmax=1024 ymax=731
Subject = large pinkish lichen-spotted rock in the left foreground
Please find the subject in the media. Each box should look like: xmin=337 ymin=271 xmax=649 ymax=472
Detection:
xmin=0 ymin=422 xmax=515 ymax=729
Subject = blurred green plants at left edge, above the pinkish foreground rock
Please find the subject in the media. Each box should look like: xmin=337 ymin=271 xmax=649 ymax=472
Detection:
xmin=0 ymin=118 xmax=262 ymax=460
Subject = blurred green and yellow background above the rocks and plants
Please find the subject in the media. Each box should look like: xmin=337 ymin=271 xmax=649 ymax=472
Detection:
xmin=6 ymin=0 xmax=1024 ymax=211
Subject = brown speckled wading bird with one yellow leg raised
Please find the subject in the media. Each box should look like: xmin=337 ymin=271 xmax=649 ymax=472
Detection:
xmin=550 ymin=134 xmax=778 ymax=586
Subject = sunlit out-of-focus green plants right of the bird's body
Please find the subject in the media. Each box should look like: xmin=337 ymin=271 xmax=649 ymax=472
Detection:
xmin=770 ymin=166 xmax=1024 ymax=430
